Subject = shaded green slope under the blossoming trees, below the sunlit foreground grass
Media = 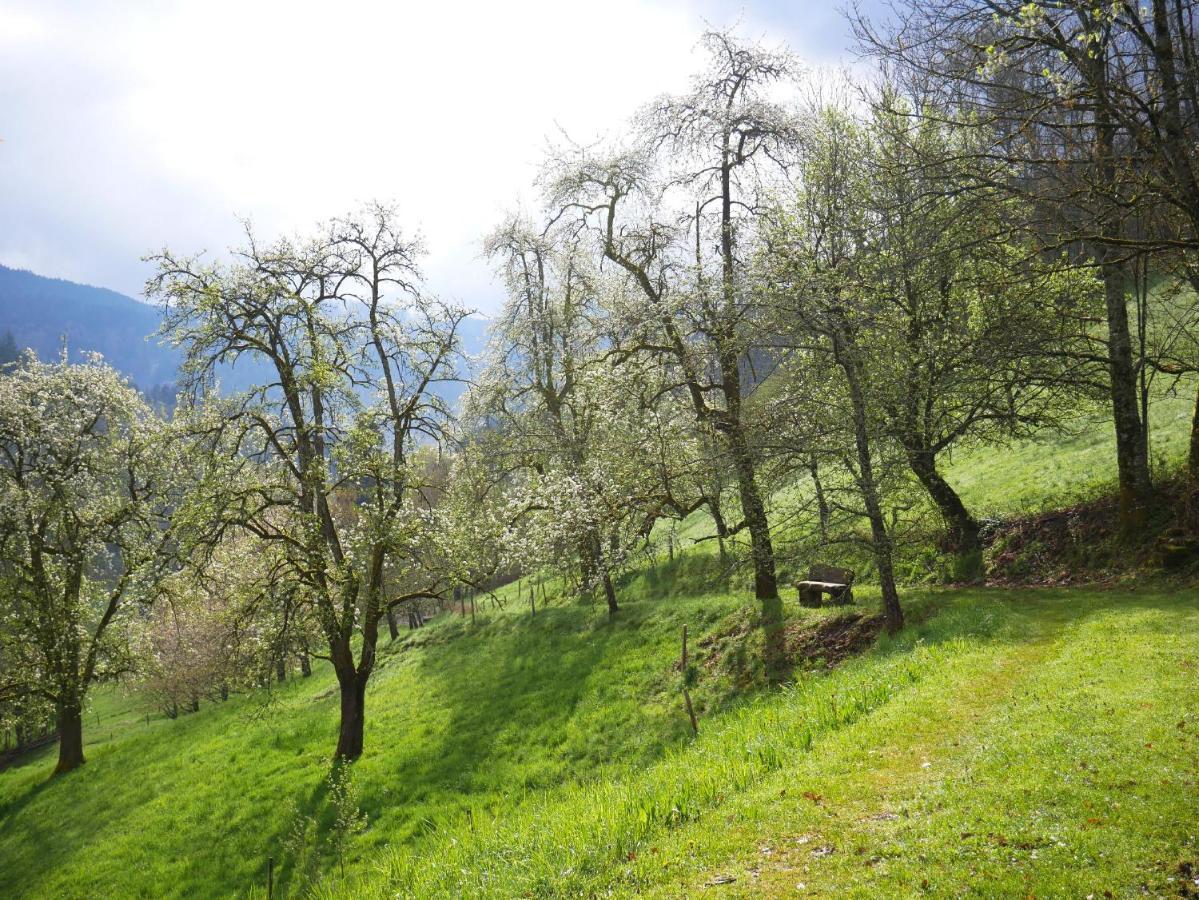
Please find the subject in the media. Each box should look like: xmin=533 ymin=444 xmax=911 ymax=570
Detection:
xmin=0 ymin=597 xmax=767 ymax=896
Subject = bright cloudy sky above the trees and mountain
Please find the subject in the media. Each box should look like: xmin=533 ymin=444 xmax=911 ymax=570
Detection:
xmin=0 ymin=0 xmax=882 ymax=314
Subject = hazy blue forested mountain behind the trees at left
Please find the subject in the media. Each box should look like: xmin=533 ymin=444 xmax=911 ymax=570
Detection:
xmin=0 ymin=266 xmax=488 ymax=400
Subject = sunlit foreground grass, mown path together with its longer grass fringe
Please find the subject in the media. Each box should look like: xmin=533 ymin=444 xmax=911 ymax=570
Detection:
xmin=324 ymin=591 xmax=1199 ymax=898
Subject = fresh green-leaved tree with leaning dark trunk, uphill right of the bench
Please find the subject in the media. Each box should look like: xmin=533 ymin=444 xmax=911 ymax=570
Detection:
xmin=853 ymin=96 xmax=1101 ymax=552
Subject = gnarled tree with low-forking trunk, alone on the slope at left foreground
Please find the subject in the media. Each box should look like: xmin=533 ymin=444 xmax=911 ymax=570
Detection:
xmin=147 ymin=205 xmax=466 ymax=760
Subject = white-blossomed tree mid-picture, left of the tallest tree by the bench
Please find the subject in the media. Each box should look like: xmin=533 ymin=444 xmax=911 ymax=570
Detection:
xmin=460 ymin=218 xmax=703 ymax=614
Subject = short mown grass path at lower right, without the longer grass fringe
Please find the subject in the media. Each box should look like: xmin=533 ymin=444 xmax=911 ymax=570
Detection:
xmin=637 ymin=591 xmax=1199 ymax=898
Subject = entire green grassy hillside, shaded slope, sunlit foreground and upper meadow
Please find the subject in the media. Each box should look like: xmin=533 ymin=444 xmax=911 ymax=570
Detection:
xmin=0 ymin=364 xmax=1199 ymax=898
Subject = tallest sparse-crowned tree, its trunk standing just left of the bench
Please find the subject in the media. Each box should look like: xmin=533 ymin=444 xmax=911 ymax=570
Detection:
xmin=546 ymin=31 xmax=800 ymax=674
